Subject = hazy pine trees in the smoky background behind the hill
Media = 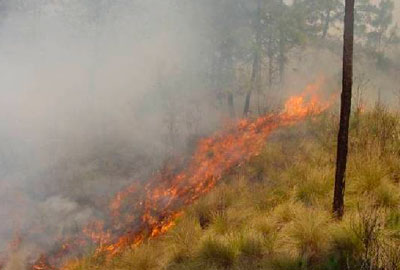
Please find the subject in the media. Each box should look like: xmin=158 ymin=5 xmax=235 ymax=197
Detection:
xmin=187 ymin=0 xmax=400 ymax=117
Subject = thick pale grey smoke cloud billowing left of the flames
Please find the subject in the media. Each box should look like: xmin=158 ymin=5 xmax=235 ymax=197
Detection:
xmin=0 ymin=0 xmax=218 ymax=260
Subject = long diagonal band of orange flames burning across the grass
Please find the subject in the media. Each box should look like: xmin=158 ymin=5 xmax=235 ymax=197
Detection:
xmin=0 ymin=79 xmax=333 ymax=270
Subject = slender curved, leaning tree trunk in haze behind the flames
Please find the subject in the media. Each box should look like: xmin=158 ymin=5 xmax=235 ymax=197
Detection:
xmin=243 ymin=0 xmax=261 ymax=117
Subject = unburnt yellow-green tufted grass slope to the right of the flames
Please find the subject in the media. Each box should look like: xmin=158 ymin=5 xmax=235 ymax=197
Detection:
xmin=65 ymin=107 xmax=400 ymax=270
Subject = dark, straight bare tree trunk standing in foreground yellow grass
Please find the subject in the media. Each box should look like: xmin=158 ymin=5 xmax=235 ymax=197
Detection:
xmin=333 ymin=0 xmax=355 ymax=219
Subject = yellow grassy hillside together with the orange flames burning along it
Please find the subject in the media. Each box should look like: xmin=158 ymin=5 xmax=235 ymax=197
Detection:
xmin=3 ymin=82 xmax=400 ymax=270
